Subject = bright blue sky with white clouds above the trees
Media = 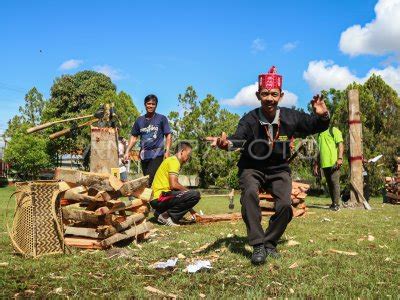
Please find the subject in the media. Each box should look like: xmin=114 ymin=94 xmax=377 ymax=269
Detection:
xmin=0 ymin=0 xmax=400 ymax=131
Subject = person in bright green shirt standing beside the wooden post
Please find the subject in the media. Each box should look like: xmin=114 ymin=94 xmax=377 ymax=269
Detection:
xmin=314 ymin=127 xmax=344 ymax=211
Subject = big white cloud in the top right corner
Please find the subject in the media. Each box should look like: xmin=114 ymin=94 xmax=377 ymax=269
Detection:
xmin=339 ymin=0 xmax=400 ymax=56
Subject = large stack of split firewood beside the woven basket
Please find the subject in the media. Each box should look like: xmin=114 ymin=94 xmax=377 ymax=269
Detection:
xmin=56 ymin=168 xmax=152 ymax=249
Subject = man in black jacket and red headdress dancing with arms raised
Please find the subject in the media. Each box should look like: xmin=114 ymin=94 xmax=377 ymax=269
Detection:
xmin=207 ymin=67 xmax=330 ymax=264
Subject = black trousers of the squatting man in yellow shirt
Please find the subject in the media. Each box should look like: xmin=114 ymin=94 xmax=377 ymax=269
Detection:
xmin=150 ymin=190 xmax=200 ymax=222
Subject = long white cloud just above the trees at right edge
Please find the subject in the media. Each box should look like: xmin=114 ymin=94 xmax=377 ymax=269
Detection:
xmin=303 ymin=60 xmax=400 ymax=93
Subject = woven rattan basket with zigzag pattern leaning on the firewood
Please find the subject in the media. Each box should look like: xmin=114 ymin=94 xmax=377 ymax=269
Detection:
xmin=7 ymin=181 xmax=65 ymax=257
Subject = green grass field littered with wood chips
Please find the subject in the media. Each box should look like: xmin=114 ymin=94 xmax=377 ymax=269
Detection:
xmin=0 ymin=188 xmax=400 ymax=299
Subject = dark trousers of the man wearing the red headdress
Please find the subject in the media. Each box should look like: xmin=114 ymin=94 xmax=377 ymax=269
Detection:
xmin=239 ymin=169 xmax=293 ymax=248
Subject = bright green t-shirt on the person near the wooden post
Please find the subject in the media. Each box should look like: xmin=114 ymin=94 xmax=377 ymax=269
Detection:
xmin=318 ymin=127 xmax=343 ymax=168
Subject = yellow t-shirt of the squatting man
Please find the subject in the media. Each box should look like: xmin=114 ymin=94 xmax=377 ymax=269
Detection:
xmin=151 ymin=155 xmax=181 ymax=199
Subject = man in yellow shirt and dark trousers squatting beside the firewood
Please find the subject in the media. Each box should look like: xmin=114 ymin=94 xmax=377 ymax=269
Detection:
xmin=150 ymin=142 xmax=200 ymax=226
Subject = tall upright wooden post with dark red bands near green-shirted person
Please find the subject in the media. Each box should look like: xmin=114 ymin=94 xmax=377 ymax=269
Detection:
xmin=348 ymin=89 xmax=364 ymax=207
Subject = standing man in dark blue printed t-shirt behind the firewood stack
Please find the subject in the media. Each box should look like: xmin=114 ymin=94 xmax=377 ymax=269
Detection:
xmin=124 ymin=95 xmax=171 ymax=187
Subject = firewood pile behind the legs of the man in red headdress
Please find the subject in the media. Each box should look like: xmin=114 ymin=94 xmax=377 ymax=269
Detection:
xmin=259 ymin=181 xmax=310 ymax=217
